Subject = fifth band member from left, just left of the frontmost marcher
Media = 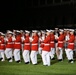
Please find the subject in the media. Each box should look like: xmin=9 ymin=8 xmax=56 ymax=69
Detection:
xmin=30 ymin=30 xmax=39 ymax=65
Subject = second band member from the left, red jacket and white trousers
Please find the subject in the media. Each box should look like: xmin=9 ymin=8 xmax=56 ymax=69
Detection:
xmin=5 ymin=30 xmax=13 ymax=62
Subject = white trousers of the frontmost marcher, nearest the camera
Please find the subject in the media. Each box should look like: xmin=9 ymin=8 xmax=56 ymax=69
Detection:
xmin=42 ymin=51 xmax=50 ymax=66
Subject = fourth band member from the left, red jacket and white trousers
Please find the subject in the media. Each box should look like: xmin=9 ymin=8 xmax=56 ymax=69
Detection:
xmin=22 ymin=30 xmax=31 ymax=64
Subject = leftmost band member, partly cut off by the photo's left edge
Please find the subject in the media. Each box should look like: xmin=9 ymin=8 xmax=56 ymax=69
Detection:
xmin=0 ymin=32 xmax=5 ymax=61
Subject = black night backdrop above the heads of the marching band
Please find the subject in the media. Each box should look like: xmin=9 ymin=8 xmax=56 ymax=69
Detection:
xmin=0 ymin=0 xmax=76 ymax=30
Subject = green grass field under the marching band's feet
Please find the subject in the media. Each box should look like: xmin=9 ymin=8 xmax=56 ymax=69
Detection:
xmin=0 ymin=54 xmax=76 ymax=75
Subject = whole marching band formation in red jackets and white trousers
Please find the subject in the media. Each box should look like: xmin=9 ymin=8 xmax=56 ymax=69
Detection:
xmin=0 ymin=28 xmax=76 ymax=66
